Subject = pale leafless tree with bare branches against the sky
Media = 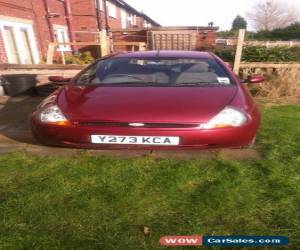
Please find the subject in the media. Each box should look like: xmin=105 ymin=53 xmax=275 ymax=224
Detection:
xmin=247 ymin=0 xmax=299 ymax=30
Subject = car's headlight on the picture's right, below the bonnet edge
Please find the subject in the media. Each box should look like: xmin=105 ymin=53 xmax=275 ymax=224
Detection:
xmin=200 ymin=107 xmax=247 ymax=129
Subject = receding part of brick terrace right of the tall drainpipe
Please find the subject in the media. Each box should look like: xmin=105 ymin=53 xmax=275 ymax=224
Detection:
xmin=69 ymin=0 xmax=160 ymax=42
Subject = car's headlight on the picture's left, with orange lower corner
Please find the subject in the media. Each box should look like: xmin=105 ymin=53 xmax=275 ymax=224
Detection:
xmin=40 ymin=105 xmax=68 ymax=125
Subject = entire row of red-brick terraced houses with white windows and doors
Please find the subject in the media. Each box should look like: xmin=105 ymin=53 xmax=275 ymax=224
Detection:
xmin=0 ymin=0 xmax=159 ymax=64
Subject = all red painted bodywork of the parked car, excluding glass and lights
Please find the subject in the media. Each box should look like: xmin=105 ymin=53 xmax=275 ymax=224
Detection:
xmin=31 ymin=51 xmax=260 ymax=149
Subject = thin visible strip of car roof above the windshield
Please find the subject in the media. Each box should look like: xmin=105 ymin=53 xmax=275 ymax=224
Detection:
xmin=113 ymin=50 xmax=213 ymax=59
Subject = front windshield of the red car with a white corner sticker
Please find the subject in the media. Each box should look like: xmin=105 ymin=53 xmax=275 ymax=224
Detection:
xmin=76 ymin=58 xmax=232 ymax=86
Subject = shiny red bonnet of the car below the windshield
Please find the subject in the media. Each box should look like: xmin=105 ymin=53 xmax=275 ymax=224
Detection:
xmin=57 ymin=85 xmax=237 ymax=123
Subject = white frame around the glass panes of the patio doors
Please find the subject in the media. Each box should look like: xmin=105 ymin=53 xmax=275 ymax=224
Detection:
xmin=0 ymin=19 xmax=40 ymax=64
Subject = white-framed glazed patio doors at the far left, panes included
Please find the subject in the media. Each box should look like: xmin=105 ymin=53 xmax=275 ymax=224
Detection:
xmin=0 ymin=20 xmax=39 ymax=64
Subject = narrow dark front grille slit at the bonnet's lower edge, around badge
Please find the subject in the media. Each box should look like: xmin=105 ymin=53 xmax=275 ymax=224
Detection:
xmin=76 ymin=121 xmax=199 ymax=128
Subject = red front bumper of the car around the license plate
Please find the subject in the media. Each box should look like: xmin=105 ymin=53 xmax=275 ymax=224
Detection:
xmin=31 ymin=114 xmax=259 ymax=150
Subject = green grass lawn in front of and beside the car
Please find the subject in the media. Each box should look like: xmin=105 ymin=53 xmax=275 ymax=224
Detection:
xmin=0 ymin=105 xmax=300 ymax=250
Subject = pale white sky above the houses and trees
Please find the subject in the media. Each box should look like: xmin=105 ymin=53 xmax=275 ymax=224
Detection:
xmin=125 ymin=0 xmax=300 ymax=30
